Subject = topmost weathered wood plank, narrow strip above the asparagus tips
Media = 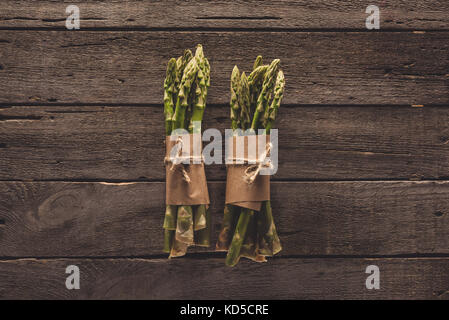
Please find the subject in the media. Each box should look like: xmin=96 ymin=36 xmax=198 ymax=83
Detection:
xmin=0 ymin=0 xmax=449 ymax=29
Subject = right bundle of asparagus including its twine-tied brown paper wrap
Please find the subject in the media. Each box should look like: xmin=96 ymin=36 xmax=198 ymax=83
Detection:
xmin=216 ymin=56 xmax=285 ymax=266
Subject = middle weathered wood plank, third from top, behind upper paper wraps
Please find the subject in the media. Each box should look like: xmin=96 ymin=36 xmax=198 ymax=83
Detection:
xmin=0 ymin=106 xmax=449 ymax=181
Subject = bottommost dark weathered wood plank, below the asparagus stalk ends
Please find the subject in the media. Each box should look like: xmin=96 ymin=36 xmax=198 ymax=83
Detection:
xmin=0 ymin=258 xmax=449 ymax=300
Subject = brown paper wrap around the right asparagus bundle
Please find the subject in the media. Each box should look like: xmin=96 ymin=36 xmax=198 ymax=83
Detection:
xmin=225 ymin=135 xmax=270 ymax=211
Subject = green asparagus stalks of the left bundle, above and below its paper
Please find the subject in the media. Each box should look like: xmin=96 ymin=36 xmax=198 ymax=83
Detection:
xmin=163 ymin=45 xmax=211 ymax=257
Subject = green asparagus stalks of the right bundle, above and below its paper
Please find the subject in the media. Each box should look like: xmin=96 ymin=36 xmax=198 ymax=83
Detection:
xmin=216 ymin=56 xmax=285 ymax=266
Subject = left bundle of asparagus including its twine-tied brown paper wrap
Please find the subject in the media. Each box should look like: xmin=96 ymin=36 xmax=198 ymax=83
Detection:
xmin=163 ymin=45 xmax=210 ymax=257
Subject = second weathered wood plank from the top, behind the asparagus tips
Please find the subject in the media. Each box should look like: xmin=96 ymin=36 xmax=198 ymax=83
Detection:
xmin=0 ymin=31 xmax=449 ymax=104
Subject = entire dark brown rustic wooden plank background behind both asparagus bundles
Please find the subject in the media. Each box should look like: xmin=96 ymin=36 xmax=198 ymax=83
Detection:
xmin=0 ymin=0 xmax=449 ymax=299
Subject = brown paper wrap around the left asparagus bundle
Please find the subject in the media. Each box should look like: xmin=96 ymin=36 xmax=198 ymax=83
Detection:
xmin=165 ymin=134 xmax=210 ymax=205
